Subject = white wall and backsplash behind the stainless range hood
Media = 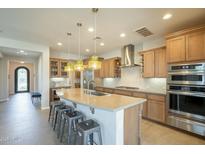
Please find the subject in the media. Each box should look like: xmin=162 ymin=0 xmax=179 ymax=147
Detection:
xmin=97 ymin=38 xmax=166 ymax=91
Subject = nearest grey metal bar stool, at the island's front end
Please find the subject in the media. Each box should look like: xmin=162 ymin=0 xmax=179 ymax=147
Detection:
xmin=77 ymin=119 xmax=102 ymax=145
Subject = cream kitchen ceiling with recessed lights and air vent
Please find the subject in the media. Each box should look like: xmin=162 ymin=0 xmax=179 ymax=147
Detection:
xmin=0 ymin=8 xmax=205 ymax=55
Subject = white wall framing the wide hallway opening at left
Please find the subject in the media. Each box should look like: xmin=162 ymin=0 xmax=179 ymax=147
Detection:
xmin=0 ymin=38 xmax=50 ymax=108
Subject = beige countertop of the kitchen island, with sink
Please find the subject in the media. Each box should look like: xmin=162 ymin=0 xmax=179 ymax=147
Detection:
xmin=60 ymin=88 xmax=146 ymax=111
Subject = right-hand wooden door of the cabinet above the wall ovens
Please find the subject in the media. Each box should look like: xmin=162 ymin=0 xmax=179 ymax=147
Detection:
xmin=186 ymin=31 xmax=205 ymax=61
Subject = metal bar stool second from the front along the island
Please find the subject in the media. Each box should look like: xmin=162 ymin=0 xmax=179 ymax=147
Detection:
xmin=60 ymin=111 xmax=84 ymax=144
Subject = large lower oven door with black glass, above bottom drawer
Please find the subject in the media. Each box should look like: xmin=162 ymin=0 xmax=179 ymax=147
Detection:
xmin=168 ymin=91 xmax=205 ymax=122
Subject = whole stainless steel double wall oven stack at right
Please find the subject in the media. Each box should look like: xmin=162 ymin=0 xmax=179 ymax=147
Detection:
xmin=167 ymin=63 xmax=205 ymax=136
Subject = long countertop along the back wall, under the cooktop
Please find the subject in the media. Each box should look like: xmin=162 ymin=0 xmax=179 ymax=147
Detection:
xmin=97 ymin=86 xmax=166 ymax=95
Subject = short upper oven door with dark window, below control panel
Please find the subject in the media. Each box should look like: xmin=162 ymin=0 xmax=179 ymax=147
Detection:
xmin=167 ymin=72 xmax=205 ymax=85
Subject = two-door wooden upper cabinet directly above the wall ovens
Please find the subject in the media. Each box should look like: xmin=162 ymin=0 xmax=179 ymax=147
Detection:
xmin=166 ymin=26 xmax=205 ymax=63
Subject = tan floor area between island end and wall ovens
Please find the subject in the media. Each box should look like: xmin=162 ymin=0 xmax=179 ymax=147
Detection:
xmin=142 ymin=120 xmax=205 ymax=145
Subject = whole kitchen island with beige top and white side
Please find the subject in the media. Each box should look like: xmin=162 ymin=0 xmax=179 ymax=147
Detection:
xmin=60 ymin=88 xmax=146 ymax=145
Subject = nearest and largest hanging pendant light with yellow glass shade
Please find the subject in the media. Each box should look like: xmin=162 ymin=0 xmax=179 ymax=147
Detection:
xmin=88 ymin=8 xmax=102 ymax=70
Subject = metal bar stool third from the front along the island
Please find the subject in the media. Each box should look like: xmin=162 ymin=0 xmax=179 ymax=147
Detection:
xmin=53 ymin=105 xmax=73 ymax=131
